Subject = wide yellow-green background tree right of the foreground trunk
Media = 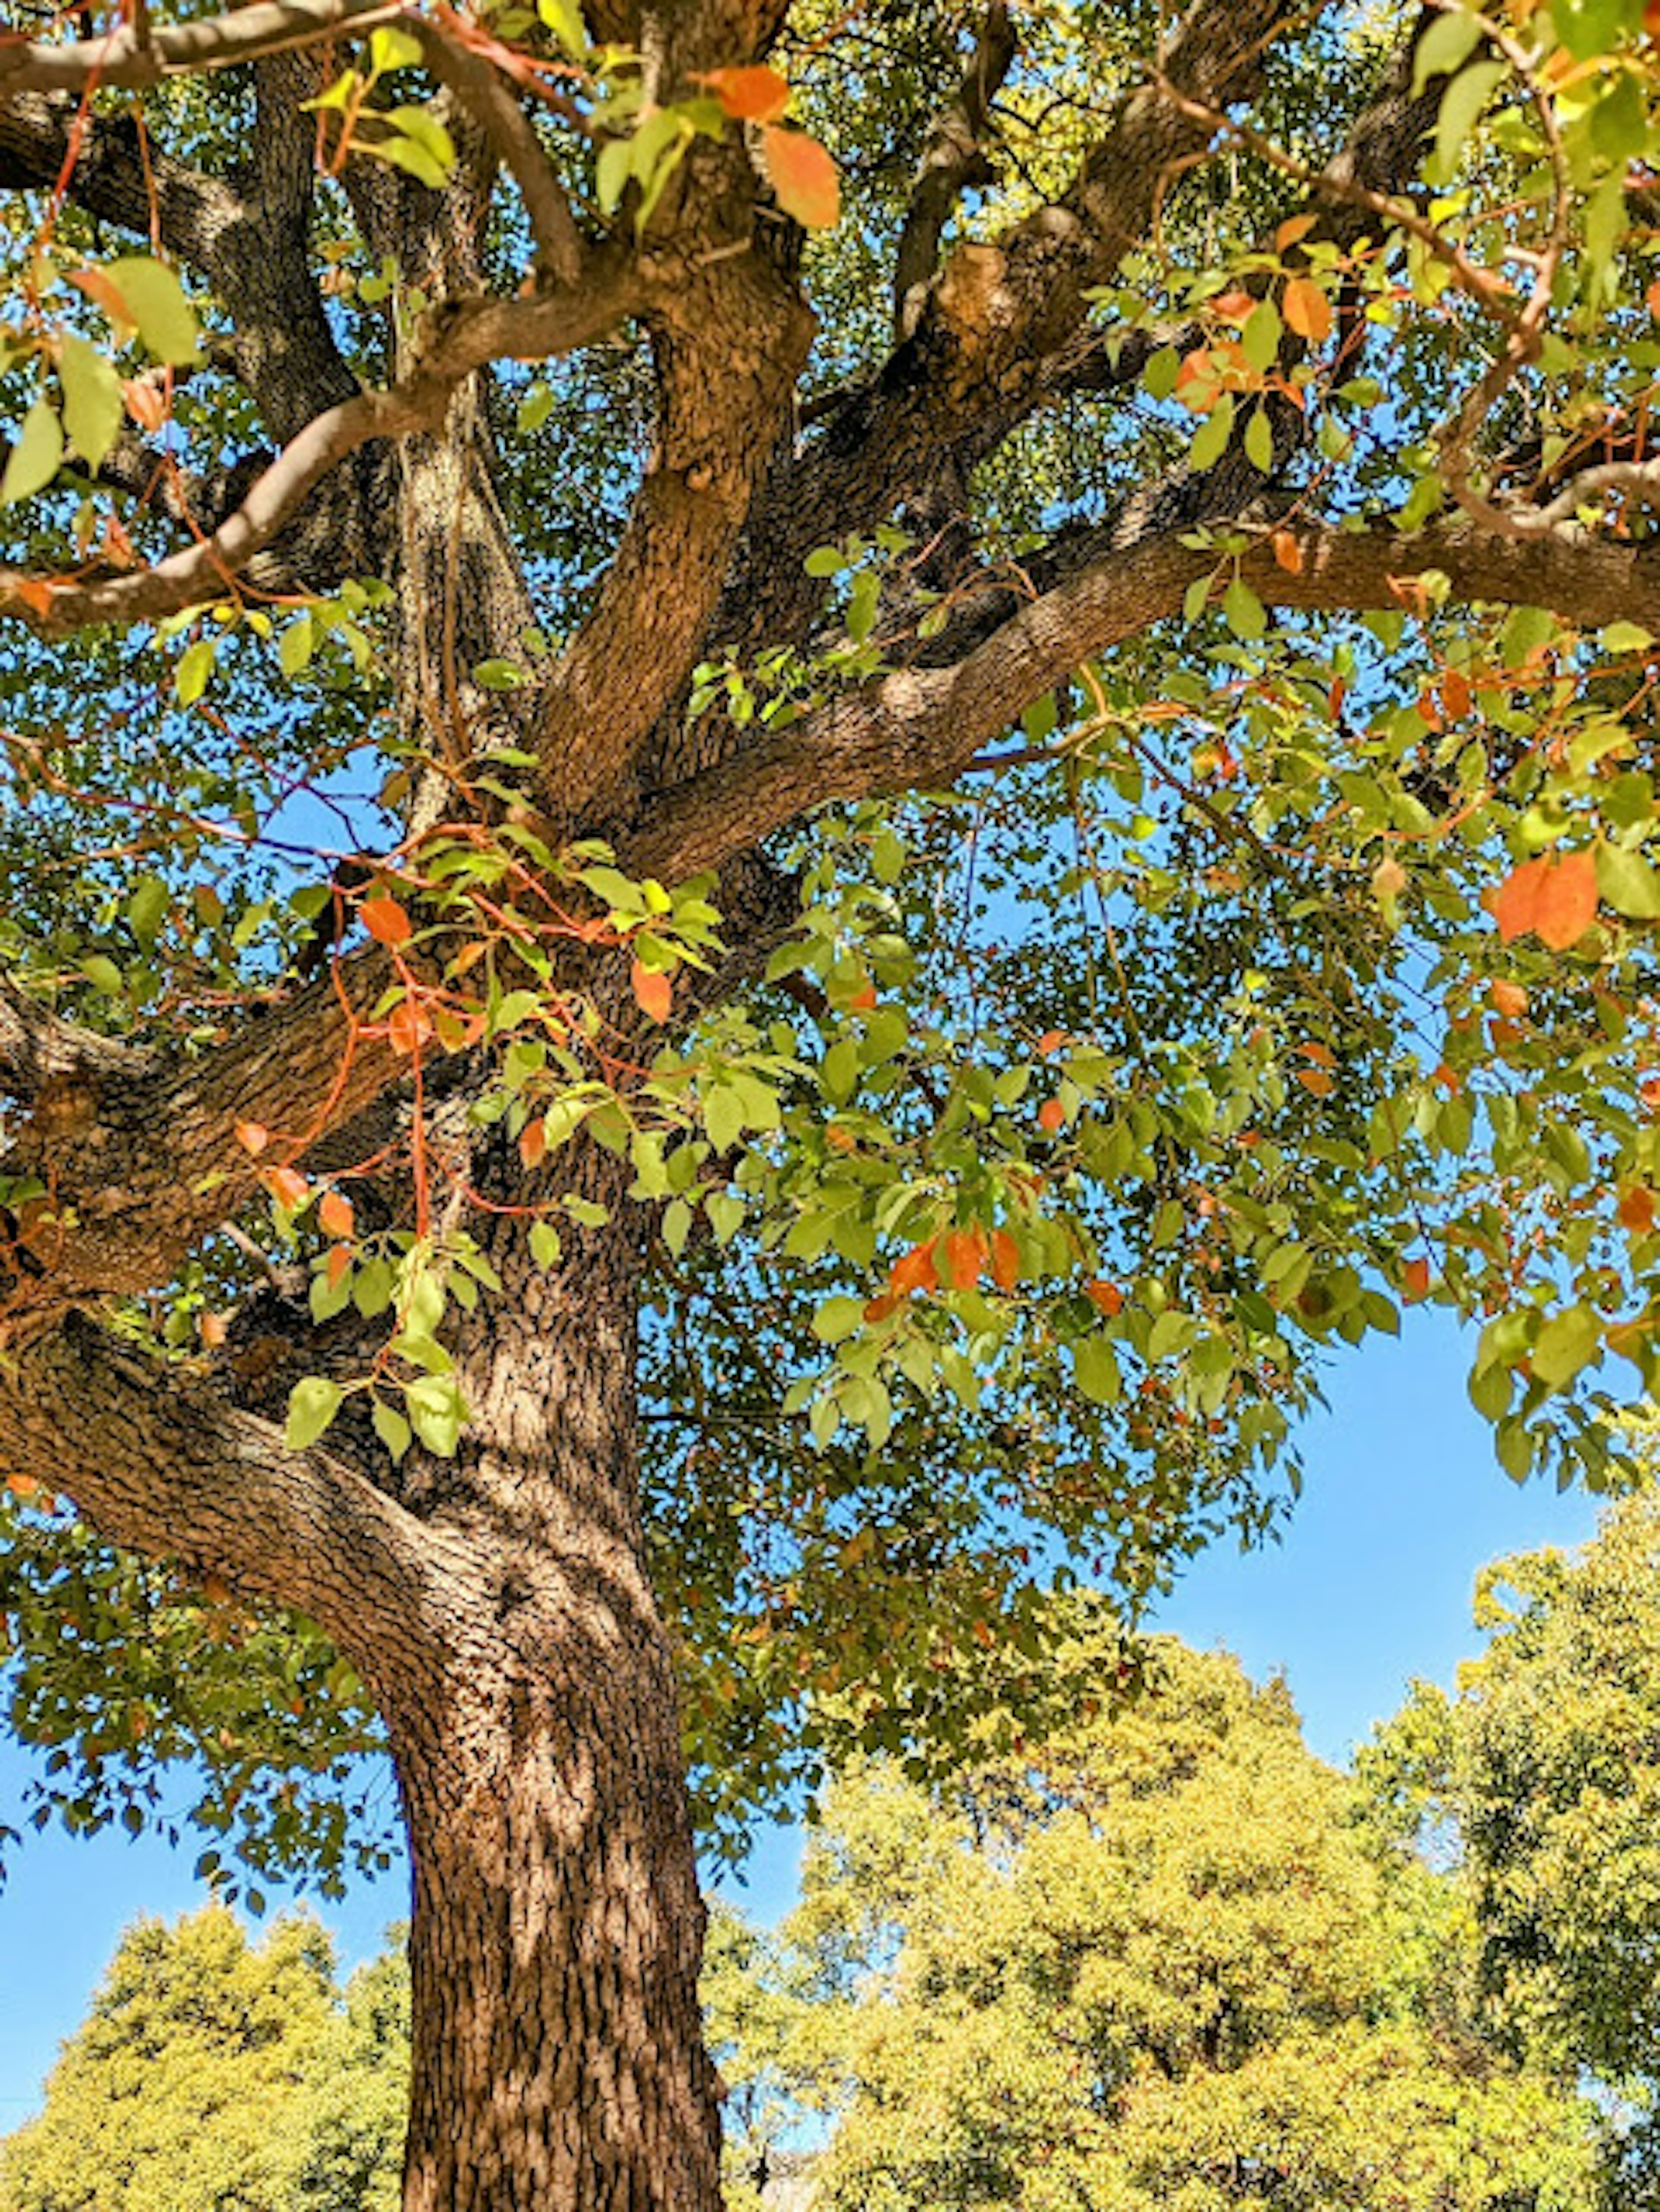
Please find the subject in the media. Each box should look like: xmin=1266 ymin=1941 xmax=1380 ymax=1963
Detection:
xmin=715 ymin=1644 xmax=1593 ymax=2212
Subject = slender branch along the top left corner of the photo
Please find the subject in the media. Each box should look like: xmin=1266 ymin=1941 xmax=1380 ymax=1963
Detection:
xmin=0 ymin=0 xmax=407 ymax=93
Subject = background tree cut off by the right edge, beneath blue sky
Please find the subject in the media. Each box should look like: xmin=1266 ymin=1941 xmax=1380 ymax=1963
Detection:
xmin=1363 ymin=1489 xmax=1660 ymax=2206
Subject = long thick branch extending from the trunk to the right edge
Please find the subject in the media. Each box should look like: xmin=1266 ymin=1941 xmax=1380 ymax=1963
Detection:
xmin=620 ymin=527 xmax=1660 ymax=883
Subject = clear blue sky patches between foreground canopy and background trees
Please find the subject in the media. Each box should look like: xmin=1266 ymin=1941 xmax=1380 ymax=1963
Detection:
xmin=0 ymin=1312 xmax=1596 ymax=2132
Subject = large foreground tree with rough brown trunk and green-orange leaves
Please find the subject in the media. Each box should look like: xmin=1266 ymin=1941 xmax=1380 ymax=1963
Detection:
xmin=0 ymin=0 xmax=1660 ymax=2212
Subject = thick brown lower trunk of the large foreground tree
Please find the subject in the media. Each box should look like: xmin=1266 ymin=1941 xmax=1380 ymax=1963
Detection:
xmin=385 ymin=1219 xmax=719 ymax=2212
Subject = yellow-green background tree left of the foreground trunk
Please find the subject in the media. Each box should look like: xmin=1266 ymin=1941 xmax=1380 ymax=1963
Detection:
xmin=0 ymin=1905 xmax=409 ymax=2212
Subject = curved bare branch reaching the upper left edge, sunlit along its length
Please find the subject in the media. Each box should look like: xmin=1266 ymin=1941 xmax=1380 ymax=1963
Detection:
xmin=0 ymin=257 xmax=638 ymax=637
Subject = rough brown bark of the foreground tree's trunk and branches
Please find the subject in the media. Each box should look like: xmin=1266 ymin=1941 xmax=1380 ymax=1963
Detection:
xmin=0 ymin=0 xmax=1660 ymax=2212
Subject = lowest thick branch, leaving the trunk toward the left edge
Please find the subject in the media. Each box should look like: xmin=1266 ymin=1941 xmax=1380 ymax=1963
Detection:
xmin=0 ymin=1314 xmax=434 ymax=1681
